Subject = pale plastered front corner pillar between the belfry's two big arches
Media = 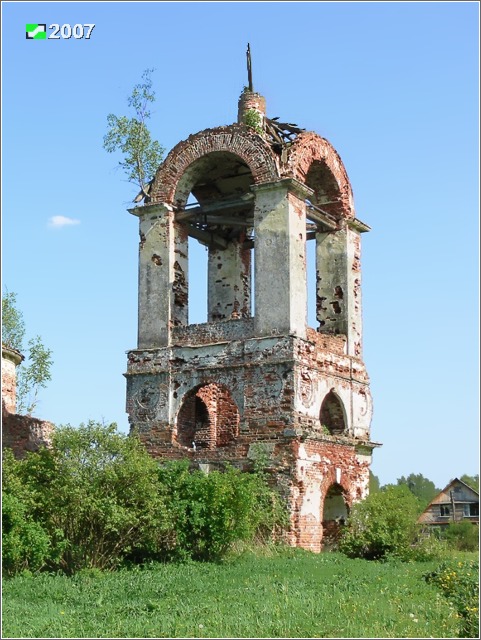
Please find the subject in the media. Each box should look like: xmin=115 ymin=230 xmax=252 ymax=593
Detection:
xmin=252 ymin=178 xmax=311 ymax=338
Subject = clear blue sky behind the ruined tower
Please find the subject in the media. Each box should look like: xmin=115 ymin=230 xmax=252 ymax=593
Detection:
xmin=2 ymin=2 xmax=479 ymax=488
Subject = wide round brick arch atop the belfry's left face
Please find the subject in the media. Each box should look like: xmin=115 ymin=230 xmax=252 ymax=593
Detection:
xmin=150 ymin=124 xmax=279 ymax=204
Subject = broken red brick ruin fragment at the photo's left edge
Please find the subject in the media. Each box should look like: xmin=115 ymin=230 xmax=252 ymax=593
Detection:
xmin=2 ymin=345 xmax=54 ymax=458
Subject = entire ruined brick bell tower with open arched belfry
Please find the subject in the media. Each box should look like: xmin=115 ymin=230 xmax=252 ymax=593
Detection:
xmin=125 ymin=55 xmax=377 ymax=551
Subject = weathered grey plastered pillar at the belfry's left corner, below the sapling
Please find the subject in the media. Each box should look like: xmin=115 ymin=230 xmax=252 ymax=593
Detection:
xmin=129 ymin=204 xmax=188 ymax=349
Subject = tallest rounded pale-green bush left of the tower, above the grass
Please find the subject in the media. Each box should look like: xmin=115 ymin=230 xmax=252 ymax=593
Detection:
xmin=16 ymin=421 xmax=168 ymax=574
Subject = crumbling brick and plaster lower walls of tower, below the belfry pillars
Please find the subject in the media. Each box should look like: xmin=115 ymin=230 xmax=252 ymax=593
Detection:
xmin=126 ymin=330 xmax=373 ymax=552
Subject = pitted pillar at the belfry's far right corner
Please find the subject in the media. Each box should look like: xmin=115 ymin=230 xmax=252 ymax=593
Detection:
xmin=316 ymin=220 xmax=362 ymax=358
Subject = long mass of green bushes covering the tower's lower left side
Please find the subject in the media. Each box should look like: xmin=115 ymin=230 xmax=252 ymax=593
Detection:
xmin=3 ymin=421 xmax=286 ymax=575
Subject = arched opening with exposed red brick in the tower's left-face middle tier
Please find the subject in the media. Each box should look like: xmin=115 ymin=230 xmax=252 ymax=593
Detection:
xmin=176 ymin=383 xmax=240 ymax=450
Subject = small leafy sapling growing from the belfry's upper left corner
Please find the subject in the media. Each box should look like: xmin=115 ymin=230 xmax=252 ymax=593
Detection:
xmin=103 ymin=69 xmax=164 ymax=195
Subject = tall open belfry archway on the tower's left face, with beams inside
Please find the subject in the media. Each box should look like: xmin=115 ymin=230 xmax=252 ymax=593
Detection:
xmin=174 ymin=151 xmax=254 ymax=322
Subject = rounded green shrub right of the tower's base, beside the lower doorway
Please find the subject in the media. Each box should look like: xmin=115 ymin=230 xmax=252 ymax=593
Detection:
xmin=339 ymin=485 xmax=419 ymax=560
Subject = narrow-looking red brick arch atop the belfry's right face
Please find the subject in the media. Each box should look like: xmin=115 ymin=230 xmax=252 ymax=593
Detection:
xmin=288 ymin=131 xmax=355 ymax=219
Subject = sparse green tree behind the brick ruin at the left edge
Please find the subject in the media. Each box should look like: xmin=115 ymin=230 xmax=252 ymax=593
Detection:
xmin=2 ymin=292 xmax=53 ymax=414
